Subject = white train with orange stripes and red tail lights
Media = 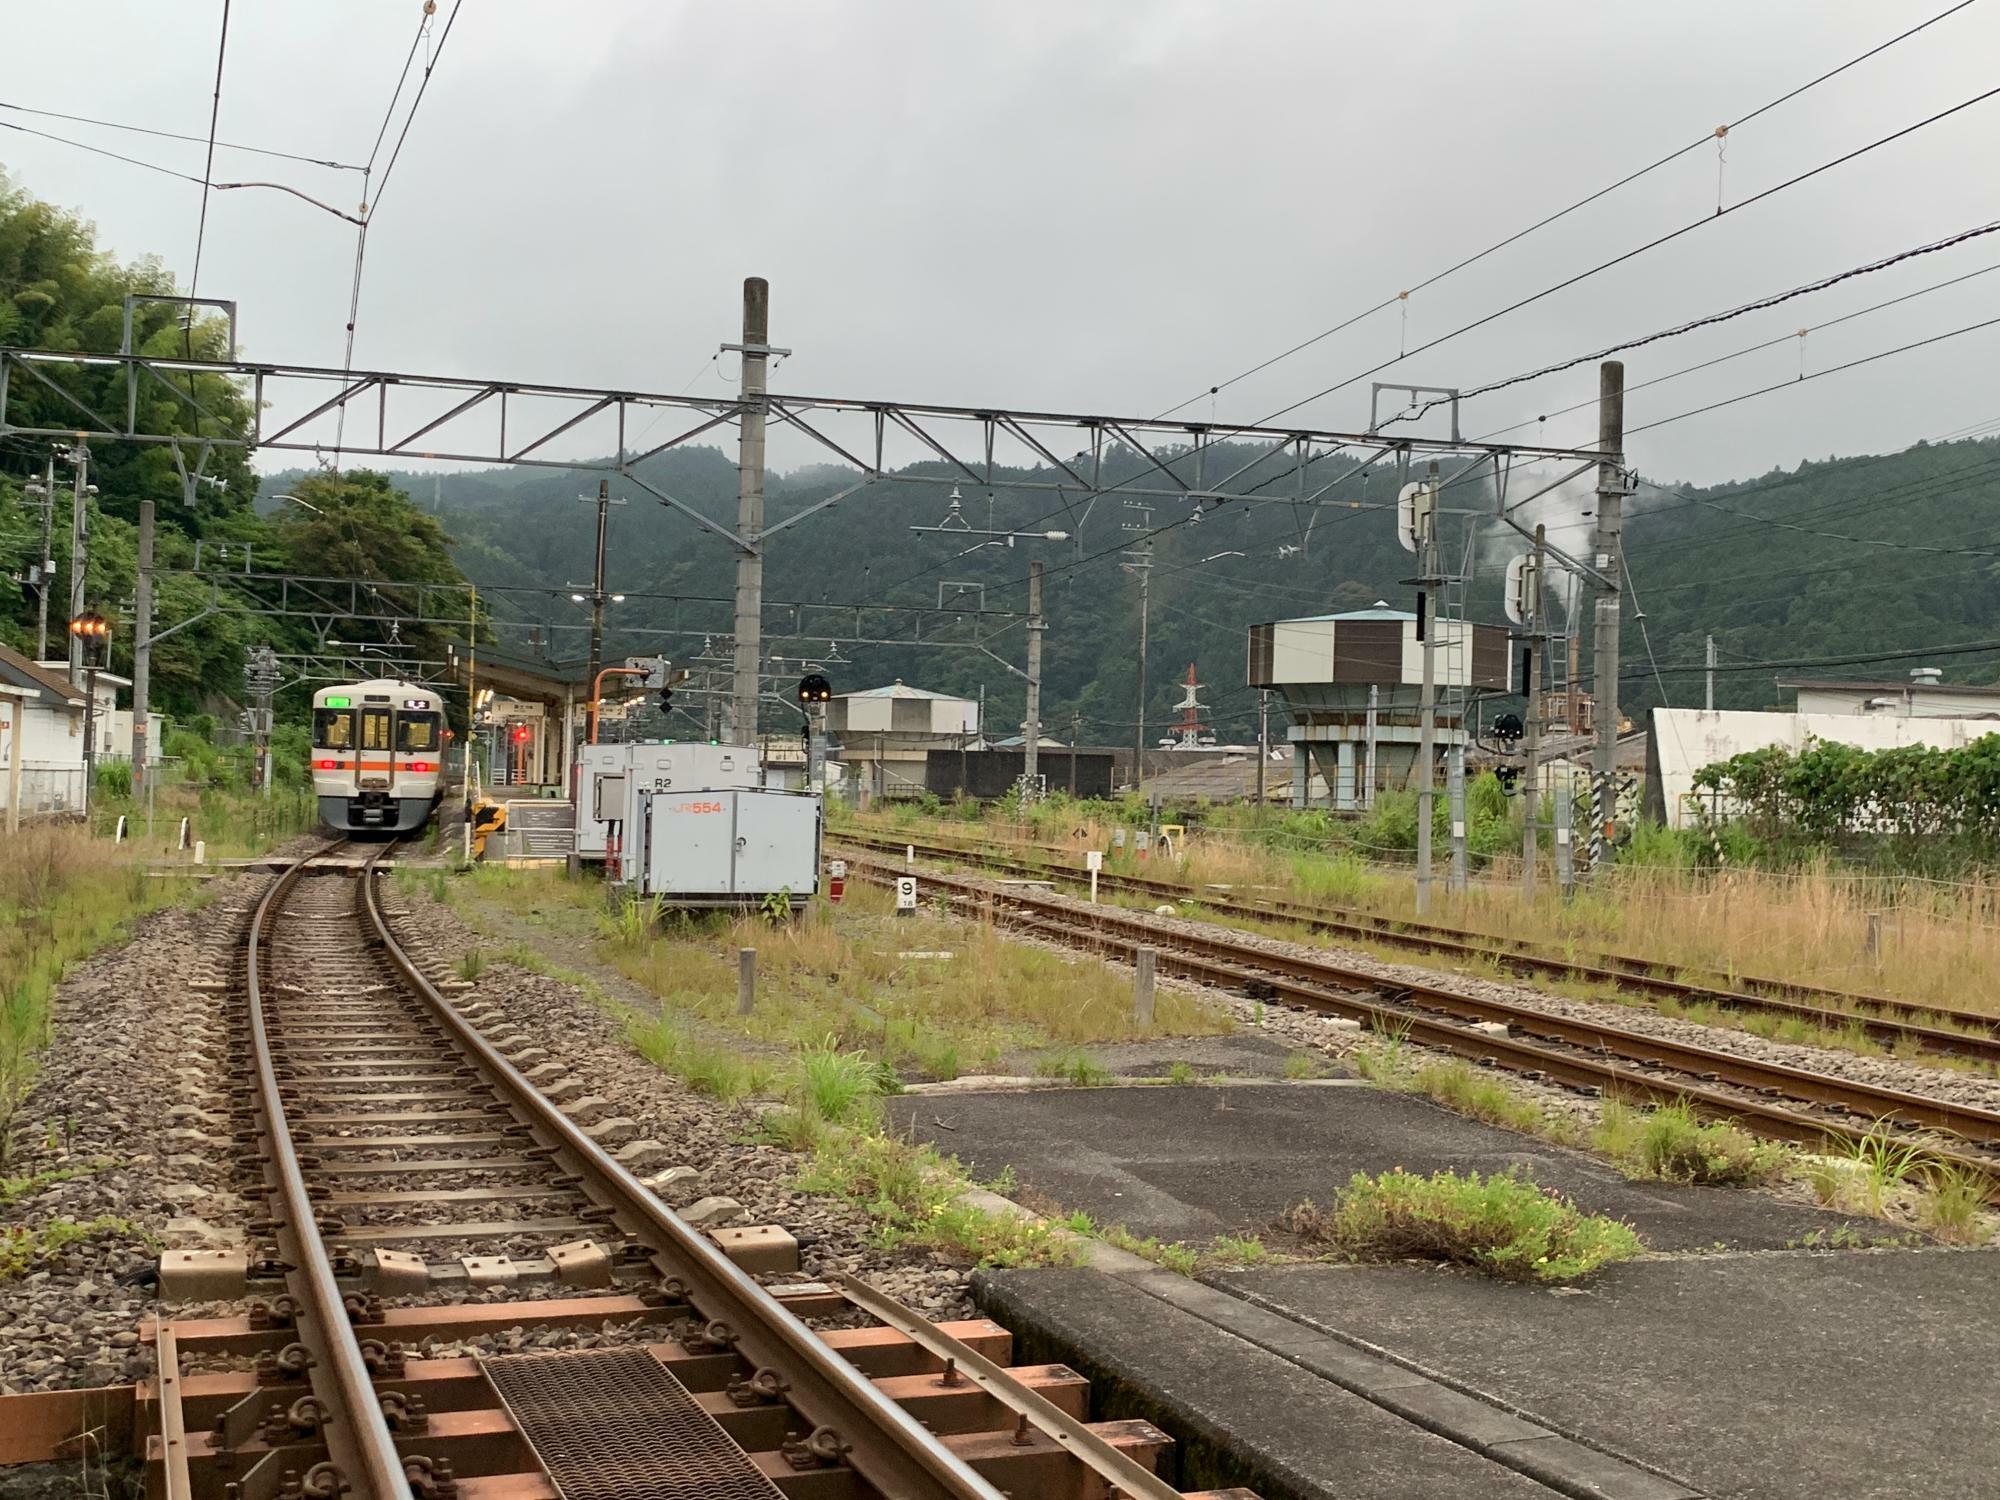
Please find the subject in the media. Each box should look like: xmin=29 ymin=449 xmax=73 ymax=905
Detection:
xmin=312 ymin=678 xmax=448 ymax=834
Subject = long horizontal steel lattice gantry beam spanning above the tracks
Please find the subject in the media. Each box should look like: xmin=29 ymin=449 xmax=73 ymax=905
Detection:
xmin=0 ymin=348 xmax=1598 ymax=552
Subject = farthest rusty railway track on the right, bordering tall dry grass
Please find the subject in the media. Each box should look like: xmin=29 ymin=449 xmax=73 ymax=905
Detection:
xmin=836 ymin=830 xmax=2000 ymax=1066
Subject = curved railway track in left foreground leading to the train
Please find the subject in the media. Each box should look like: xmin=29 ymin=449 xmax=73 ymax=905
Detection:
xmin=136 ymin=844 xmax=1250 ymax=1500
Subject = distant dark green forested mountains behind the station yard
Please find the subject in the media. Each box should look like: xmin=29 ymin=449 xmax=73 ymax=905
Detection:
xmin=316 ymin=424 xmax=2000 ymax=744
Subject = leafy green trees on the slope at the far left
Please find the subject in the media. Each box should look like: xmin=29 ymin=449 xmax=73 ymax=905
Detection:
xmin=0 ymin=176 xmax=458 ymax=716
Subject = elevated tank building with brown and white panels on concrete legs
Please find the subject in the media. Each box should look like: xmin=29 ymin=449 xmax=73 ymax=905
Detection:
xmin=1248 ymin=604 xmax=1512 ymax=812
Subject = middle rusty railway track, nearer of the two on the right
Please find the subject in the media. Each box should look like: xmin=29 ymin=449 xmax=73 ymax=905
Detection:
xmin=832 ymin=854 xmax=2000 ymax=1202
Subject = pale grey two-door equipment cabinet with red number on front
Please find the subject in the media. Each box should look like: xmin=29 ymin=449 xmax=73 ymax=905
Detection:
xmin=644 ymin=788 xmax=822 ymax=906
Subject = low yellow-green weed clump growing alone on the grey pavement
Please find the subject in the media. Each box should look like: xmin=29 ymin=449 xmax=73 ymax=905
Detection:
xmin=1288 ymin=1168 xmax=1644 ymax=1282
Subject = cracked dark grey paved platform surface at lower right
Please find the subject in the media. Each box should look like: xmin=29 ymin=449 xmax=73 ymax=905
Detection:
xmin=888 ymin=1080 xmax=2000 ymax=1500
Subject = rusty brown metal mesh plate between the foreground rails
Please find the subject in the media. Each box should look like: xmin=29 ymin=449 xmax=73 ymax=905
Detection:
xmin=480 ymin=1348 xmax=782 ymax=1500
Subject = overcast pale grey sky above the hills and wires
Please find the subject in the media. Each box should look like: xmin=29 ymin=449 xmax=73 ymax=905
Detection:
xmin=0 ymin=0 xmax=2000 ymax=482
